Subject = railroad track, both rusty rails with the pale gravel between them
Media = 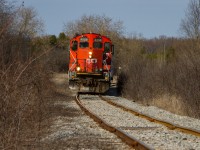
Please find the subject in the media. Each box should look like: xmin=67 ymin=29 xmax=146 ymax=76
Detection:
xmin=77 ymin=95 xmax=200 ymax=149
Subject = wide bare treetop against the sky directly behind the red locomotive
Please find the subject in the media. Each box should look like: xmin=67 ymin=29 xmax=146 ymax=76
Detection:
xmin=64 ymin=15 xmax=123 ymax=38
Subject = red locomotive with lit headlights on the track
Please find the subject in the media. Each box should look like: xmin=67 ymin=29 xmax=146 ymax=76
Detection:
xmin=68 ymin=33 xmax=114 ymax=93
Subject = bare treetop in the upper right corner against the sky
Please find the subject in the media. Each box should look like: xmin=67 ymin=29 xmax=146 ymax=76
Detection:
xmin=180 ymin=0 xmax=200 ymax=40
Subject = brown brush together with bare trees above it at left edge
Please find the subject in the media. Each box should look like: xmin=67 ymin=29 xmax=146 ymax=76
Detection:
xmin=0 ymin=0 xmax=55 ymax=149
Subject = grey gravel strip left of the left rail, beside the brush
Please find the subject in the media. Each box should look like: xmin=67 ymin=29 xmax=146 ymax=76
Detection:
xmin=42 ymin=97 xmax=132 ymax=150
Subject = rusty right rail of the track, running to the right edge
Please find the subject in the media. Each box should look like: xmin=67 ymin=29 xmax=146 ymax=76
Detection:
xmin=99 ymin=96 xmax=200 ymax=137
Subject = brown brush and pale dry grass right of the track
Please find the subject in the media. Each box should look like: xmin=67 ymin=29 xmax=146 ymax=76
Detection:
xmin=118 ymin=38 xmax=200 ymax=118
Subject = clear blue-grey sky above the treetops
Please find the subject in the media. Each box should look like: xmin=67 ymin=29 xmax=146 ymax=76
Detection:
xmin=12 ymin=0 xmax=189 ymax=38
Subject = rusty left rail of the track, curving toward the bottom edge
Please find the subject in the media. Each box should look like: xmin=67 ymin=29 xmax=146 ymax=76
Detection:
xmin=76 ymin=95 xmax=153 ymax=150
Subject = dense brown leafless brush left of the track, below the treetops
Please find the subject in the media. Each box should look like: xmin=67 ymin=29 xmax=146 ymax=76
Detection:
xmin=0 ymin=43 xmax=55 ymax=149
